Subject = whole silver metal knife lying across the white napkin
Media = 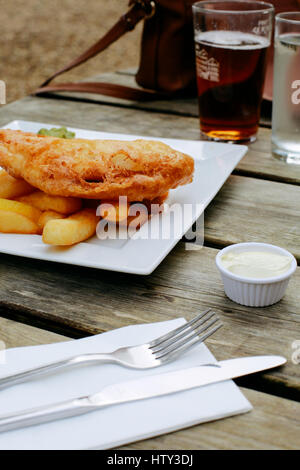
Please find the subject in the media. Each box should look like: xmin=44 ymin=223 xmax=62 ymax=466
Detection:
xmin=0 ymin=356 xmax=286 ymax=432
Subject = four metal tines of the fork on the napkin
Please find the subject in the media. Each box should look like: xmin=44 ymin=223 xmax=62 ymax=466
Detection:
xmin=149 ymin=309 xmax=222 ymax=362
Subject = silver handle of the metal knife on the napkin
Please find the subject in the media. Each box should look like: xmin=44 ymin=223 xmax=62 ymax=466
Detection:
xmin=0 ymin=397 xmax=99 ymax=432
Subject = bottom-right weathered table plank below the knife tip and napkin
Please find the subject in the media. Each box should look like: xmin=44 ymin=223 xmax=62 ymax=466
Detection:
xmin=122 ymin=389 xmax=300 ymax=450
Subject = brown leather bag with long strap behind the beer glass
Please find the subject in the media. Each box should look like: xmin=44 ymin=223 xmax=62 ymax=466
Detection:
xmin=35 ymin=0 xmax=300 ymax=101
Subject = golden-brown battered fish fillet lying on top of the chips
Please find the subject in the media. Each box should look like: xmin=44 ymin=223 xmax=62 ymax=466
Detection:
xmin=0 ymin=130 xmax=194 ymax=201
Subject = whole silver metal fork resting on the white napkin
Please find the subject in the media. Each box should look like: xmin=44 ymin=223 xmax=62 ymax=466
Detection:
xmin=0 ymin=309 xmax=222 ymax=389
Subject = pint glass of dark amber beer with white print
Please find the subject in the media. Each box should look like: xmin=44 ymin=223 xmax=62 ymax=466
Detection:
xmin=193 ymin=0 xmax=274 ymax=143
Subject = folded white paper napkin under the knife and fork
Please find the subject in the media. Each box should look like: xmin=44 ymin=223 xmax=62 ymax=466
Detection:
xmin=0 ymin=318 xmax=252 ymax=450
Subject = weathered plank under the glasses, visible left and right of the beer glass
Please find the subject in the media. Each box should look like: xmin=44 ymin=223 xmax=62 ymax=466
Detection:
xmin=0 ymin=97 xmax=300 ymax=184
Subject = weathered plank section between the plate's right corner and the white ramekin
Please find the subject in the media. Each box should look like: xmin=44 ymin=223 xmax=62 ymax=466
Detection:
xmin=205 ymin=175 xmax=300 ymax=261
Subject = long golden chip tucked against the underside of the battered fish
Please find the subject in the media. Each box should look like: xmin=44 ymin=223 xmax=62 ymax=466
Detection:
xmin=17 ymin=191 xmax=82 ymax=215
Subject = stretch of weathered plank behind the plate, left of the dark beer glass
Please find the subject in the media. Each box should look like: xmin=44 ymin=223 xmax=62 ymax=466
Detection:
xmin=0 ymin=96 xmax=200 ymax=140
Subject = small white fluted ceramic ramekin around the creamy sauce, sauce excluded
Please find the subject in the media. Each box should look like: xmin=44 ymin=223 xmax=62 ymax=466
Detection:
xmin=216 ymin=243 xmax=297 ymax=307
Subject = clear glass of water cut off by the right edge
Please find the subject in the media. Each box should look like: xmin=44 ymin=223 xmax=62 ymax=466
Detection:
xmin=272 ymin=13 xmax=300 ymax=164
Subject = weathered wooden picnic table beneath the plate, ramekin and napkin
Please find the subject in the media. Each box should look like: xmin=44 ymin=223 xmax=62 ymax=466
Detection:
xmin=0 ymin=71 xmax=300 ymax=449
